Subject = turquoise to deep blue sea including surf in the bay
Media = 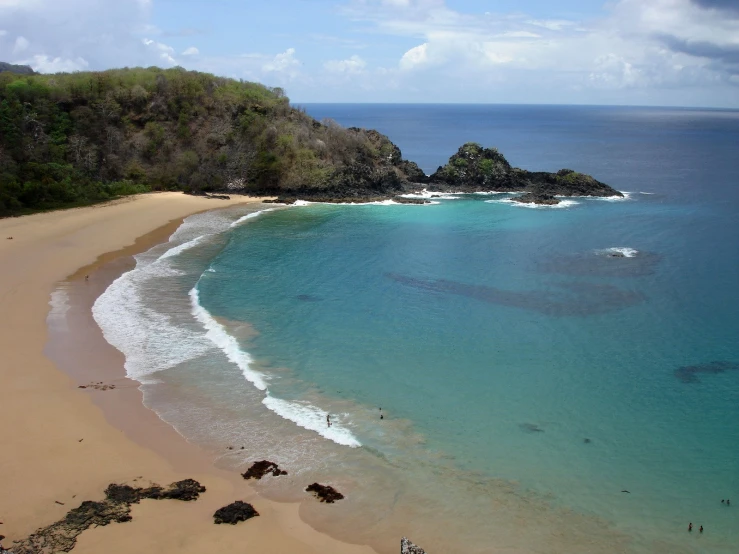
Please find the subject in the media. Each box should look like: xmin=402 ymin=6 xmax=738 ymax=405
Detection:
xmin=95 ymin=104 xmax=739 ymax=553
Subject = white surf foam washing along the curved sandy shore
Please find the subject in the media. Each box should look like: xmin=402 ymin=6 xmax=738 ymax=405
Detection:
xmin=93 ymin=203 xmax=361 ymax=447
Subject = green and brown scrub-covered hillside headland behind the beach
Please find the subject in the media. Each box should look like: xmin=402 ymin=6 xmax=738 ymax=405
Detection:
xmin=0 ymin=68 xmax=425 ymax=216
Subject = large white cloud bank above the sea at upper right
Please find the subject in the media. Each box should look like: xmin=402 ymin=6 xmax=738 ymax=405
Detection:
xmin=345 ymin=0 xmax=739 ymax=102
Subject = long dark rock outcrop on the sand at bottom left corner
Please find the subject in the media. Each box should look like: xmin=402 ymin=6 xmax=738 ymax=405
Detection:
xmin=13 ymin=479 xmax=205 ymax=554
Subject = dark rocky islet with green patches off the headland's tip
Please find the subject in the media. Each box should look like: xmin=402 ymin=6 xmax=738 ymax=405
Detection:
xmin=428 ymin=142 xmax=623 ymax=196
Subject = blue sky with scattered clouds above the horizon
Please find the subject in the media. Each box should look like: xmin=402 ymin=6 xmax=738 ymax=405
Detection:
xmin=0 ymin=0 xmax=739 ymax=108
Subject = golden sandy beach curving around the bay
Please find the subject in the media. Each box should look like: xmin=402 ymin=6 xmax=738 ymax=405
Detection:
xmin=0 ymin=193 xmax=374 ymax=554
